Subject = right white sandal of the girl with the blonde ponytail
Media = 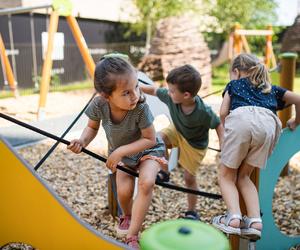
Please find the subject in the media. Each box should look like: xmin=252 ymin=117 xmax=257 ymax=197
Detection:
xmin=241 ymin=215 xmax=262 ymax=240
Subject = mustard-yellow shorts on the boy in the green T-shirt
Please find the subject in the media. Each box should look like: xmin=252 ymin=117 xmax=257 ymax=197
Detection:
xmin=160 ymin=124 xmax=207 ymax=176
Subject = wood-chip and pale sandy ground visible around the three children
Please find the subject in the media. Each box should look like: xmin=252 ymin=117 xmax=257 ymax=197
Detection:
xmin=0 ymin=90 xmax=300 ymax=246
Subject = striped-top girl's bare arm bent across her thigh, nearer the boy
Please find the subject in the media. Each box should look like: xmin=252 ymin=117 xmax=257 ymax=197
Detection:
xmin=106 ymin=125 xmax=156 ymax=172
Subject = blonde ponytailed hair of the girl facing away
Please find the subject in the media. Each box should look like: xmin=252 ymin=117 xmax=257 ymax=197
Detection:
xmin=231 ymin=53 xmax=272 ymax=93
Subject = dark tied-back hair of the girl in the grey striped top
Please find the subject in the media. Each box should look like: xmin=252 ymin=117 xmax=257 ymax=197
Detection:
xmin=94 ymin=57 xmax=136 ymax=95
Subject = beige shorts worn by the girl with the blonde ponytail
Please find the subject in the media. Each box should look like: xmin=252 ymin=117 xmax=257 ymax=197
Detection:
xmin=221 ymin=106 xmax=281 ymax=168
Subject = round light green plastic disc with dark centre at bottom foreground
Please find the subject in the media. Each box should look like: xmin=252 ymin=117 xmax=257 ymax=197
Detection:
xmin=140 ymin=219 xmax=230 ymax=250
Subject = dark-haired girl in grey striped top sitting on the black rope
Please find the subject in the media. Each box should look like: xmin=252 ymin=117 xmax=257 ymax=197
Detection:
xmin=68 ymin=57 xmax=167 ymax=248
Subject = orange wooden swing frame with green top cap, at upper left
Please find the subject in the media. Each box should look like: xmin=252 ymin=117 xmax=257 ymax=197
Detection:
xmin=0 ymin=0 xmax=95 ymax=119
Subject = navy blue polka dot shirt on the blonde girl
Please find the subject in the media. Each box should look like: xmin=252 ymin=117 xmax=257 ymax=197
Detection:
xmin=223 ymin=78 xmax=286 ymax=114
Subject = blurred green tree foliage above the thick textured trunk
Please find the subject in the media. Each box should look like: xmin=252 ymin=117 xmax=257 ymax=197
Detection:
xmin=132 ymin=0 xmax=277 ymax=53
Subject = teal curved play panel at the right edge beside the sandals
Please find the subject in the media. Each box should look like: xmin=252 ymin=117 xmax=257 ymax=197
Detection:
xmin=256 ymin=126 xmax=300 ymax=250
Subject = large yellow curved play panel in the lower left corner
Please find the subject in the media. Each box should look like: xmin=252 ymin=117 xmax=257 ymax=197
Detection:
xmin=0 ymin=137 xmax=126 ymax=250
